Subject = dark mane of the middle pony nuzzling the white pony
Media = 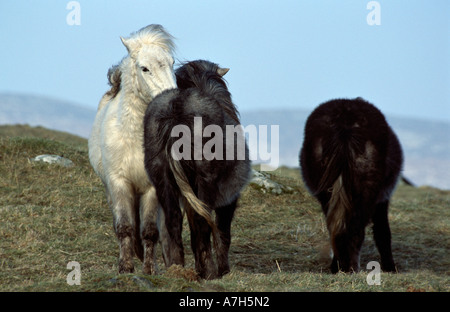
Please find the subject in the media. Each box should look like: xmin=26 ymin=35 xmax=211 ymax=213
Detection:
xmin=175 ymin=60 xmax=240 ymax=123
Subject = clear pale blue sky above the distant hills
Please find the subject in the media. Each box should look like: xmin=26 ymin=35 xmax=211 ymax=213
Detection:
xmin=0 ymin=0 xmax=450 ymax=121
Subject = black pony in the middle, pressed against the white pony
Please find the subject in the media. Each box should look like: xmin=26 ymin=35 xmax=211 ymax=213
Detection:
xmin=144 ymin=60 xmax=251 ymax=279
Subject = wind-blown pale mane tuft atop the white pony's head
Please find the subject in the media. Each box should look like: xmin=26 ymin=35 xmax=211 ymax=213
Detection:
xmin=129 ymin=24 xmax=175 ymax=53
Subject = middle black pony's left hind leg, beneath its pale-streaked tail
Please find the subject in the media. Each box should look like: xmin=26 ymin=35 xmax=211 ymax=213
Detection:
xmin=185 ymin=203 xmax=216 ymax=279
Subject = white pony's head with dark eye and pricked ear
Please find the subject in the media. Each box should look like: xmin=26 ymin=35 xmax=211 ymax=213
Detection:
xmin=120 ymin=24 xmax=176 ymax=101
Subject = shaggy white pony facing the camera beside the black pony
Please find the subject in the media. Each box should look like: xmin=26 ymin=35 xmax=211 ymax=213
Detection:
xmin=89 ymin=25 xmax=176 ymax=274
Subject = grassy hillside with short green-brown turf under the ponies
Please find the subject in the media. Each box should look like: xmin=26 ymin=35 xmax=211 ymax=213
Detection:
xmin=0 ymin=127 xmax=450 ymax=291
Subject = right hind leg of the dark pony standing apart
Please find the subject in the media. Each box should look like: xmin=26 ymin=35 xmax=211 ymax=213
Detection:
xmin=372 ymin=201 xmax=396 ymax=272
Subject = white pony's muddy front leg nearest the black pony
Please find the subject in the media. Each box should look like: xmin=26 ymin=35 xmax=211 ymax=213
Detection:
xmin=140 ymin=186 xmax=159 ymax=274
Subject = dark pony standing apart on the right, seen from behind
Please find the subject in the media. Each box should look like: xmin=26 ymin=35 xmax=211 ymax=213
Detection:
xmin=300 ymin=98 xmax=403 ymax=273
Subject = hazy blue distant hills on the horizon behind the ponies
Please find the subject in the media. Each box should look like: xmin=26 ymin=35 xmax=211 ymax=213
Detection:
xmin=0 ymin=94 xmax=450 ymax=189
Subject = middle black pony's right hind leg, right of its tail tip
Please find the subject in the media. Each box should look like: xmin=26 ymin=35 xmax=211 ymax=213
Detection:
xmin=216 ymin=199 xmax=237 ymax=276
